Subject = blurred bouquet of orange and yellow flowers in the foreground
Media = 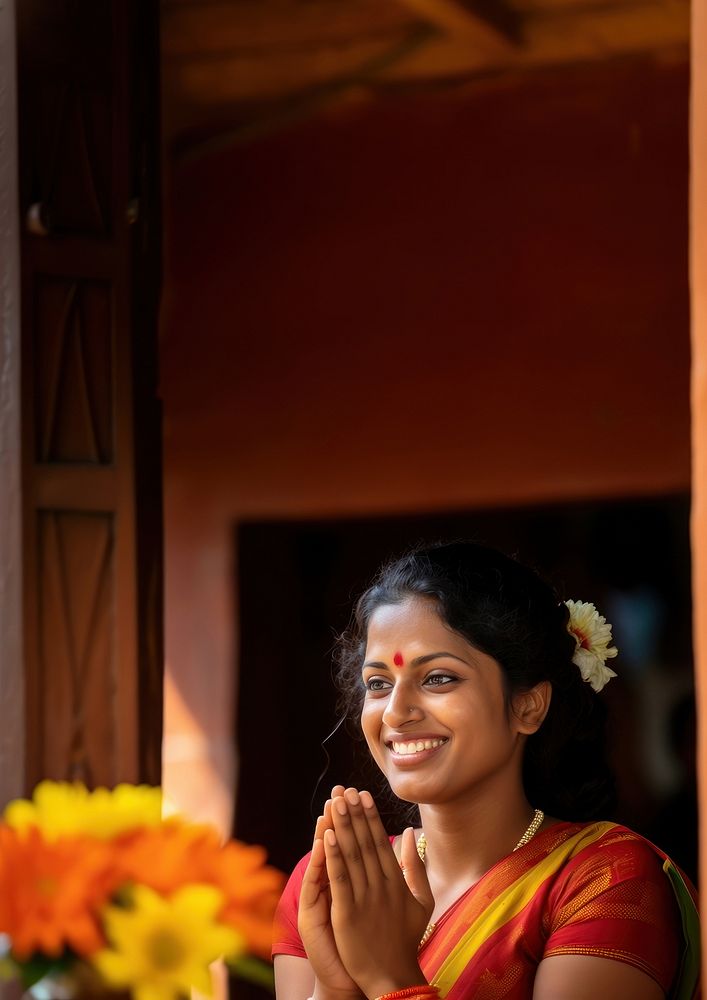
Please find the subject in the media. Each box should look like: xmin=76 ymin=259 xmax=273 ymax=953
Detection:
xmin=0 ymin=781 xmax=283 ymax=1000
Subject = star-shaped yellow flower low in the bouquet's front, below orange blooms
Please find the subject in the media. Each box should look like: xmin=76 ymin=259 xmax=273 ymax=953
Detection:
xmin=92 ymin=885 xmax=244 ymax=1000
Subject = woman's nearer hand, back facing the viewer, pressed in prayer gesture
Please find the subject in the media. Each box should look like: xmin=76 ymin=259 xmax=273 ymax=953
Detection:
xmin=324 ymin=788 xmax=434 ymax=997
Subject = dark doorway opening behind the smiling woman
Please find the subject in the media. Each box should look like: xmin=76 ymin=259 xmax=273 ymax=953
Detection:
xmin=235 ymin=496 xmax=694 ymax=884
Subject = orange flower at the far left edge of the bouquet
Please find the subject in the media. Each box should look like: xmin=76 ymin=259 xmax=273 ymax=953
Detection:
xmin=0 ymin=826 xmax=119 ymax=960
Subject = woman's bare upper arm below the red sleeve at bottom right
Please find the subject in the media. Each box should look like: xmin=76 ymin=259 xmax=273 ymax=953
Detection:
xmin=533 ymin=955 xmax=665 ymax=1000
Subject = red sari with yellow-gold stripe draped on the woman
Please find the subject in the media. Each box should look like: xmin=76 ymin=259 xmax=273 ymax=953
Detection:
xmin=273 ymin=822 xmax=699 ymax=1000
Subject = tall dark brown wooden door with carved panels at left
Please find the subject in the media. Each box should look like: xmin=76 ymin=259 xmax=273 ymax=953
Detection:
xmin=17 ymin=0 xmax=162 ymax=787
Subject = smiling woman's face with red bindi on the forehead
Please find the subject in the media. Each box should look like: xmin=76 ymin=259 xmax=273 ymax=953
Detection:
xmin=361 ymin=597 xmax=522 ymax=803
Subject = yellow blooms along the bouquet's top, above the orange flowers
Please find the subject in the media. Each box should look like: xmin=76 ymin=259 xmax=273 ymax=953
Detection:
xmin=4 ymin=781 xmax=162 ymax=841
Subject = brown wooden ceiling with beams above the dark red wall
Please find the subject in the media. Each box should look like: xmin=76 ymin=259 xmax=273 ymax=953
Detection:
xmin=162 ymin=0 xmax=689 ymax=152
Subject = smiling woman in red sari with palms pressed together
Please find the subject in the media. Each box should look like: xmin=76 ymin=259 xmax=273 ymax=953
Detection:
xmin=273 ymin=543 xmax=698 ymax=1000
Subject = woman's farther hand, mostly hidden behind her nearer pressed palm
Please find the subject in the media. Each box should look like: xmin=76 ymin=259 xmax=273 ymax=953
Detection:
xmin=297 ymin=785 xmax=361 ymax=1000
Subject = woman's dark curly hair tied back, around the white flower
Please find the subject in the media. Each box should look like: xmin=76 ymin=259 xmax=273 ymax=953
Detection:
xmin=337 ymin=542 xmax=614 ymax=821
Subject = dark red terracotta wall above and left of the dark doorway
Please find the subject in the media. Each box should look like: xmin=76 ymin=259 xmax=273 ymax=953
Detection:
xmin=162 ymin=60 xmax=690 ymax=836
